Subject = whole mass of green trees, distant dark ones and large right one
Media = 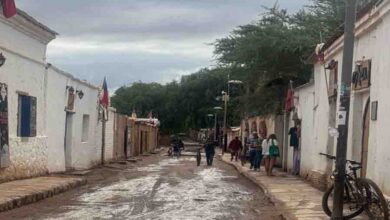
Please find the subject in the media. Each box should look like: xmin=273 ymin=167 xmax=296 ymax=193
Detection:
xmin=112 ymin=0 xmax=344 ymax=133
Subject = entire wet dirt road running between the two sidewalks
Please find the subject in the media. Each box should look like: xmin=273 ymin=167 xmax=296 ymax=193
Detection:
xmin=0 ymin=156 xmax=282 ymax=220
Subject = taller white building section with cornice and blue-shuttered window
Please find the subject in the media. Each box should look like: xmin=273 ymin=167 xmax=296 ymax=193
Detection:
xmin=0 ymin=11 xmax=56 ymax=181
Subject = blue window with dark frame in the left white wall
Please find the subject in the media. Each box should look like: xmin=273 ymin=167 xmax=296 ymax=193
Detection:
xmin=18 ymin=95 xmax=37 ymax=137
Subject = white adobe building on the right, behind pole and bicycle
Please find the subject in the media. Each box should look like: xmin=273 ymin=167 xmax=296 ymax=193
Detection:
xmin=289 ymin=1 xmax=390 ymax=195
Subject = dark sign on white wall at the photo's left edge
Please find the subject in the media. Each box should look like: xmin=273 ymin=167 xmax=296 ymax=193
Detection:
xmin=0 ymin=83 xmax=10 ymax=168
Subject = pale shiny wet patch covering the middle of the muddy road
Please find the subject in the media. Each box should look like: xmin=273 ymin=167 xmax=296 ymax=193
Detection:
xmin=42 ymin=158 xmax=253 ymax=220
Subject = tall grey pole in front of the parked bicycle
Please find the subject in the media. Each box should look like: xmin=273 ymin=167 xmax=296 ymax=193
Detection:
xmin=332 ymin=0 xmax=356 ymax=220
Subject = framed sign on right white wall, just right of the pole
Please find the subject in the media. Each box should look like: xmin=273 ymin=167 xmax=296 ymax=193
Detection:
xmin=352 ymin=60 xmax=371 ymax=91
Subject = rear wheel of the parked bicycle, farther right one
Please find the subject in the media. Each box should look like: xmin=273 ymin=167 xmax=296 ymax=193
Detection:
xmin=356 ymin=178 xmax=389 ymax=220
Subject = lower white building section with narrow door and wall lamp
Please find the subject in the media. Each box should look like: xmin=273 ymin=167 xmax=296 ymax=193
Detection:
xmin=45 ymin=64 xmax=103 ymax=172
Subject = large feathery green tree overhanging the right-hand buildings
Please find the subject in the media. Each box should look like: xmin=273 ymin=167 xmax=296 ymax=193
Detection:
xmin=214 ymin=0 xmax=344 ymax=115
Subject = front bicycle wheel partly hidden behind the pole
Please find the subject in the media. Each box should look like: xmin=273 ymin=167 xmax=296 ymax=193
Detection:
xmin=322 ymin=184 xmax=364 ymax=219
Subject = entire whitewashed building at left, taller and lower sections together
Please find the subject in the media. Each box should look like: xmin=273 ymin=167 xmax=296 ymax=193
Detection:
xmin=0 ymin=10 xmax=101 ymax=182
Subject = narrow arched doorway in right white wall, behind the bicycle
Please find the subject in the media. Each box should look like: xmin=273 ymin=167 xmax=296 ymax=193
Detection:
xmin=361 ymin=99 xmax=371 ymax=177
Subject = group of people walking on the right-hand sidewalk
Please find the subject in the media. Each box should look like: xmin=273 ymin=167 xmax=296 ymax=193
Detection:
xmin=229 ymin=132 xmax=280 ymax=176
